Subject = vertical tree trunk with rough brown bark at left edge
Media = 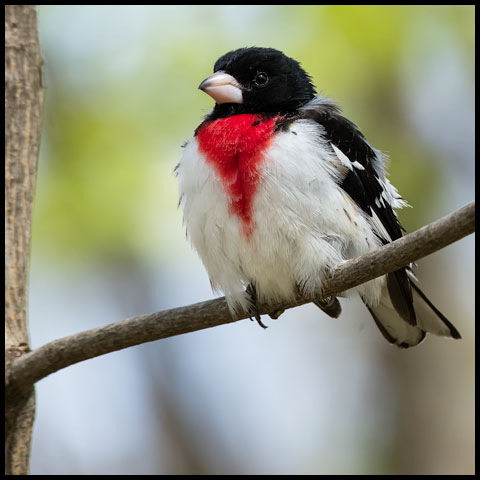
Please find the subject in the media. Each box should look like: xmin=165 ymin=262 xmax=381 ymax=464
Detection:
xmin=5 ymin=5 xmax=43 ymax=474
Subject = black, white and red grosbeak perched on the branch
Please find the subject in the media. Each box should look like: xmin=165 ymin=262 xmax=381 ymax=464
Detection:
xmin=175 ymin=46 xmax=461 ymax=348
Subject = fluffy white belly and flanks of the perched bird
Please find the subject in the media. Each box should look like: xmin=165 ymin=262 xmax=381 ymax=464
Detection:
xmin=178 ymin=120 xmax=383 ymax=309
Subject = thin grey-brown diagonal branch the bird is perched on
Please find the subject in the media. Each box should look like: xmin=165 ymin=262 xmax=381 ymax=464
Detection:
xmin=7 ymin=202 xmax=475 ymax=387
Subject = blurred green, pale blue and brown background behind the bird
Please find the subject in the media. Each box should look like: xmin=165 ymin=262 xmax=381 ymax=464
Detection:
xmin=29 ymin=5 xmax=475 ymax=474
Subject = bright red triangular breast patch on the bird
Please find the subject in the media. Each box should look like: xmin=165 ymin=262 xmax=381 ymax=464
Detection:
xmin=197 ymin=114 xmax=276 ymax=237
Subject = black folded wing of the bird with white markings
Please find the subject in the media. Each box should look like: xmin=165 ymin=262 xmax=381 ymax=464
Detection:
xmin=301 ymin=101 xmax=416 ymax=325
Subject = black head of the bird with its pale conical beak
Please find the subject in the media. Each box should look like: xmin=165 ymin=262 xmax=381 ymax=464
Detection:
xmin=199 ymin=47 xmax=316 ymax=118
